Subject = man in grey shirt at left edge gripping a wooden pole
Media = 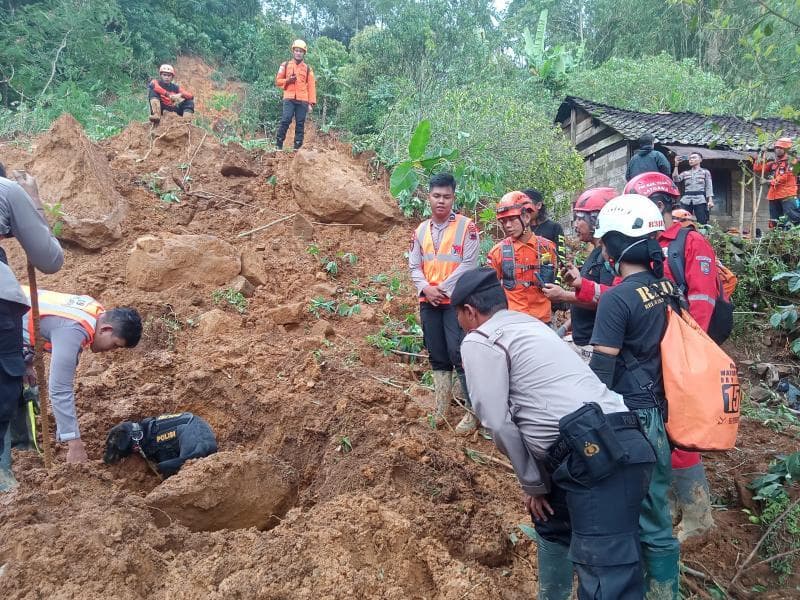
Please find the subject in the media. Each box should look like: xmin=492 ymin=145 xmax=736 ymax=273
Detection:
xmin=0 ymin=165 xmax=64 ymax=493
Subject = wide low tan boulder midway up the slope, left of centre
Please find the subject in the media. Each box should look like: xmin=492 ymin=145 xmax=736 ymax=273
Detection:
xmin=127 ymin=233 xmax=242 ymax=292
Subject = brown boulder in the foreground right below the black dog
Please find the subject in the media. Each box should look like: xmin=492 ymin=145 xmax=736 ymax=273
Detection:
xmin=145 ymin=451 xmax=296 ymax=531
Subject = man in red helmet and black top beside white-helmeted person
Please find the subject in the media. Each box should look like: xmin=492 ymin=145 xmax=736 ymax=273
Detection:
xmin=543 ymin=187 xmax=619 ymax=362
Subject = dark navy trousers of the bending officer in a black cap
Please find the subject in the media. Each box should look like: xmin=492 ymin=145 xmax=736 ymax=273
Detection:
xmin=533 ymin=413 xmax=655 ymax=600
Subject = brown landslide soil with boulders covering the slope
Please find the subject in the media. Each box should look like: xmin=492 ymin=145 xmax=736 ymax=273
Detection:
xmin=0 ymin=59 xmax=792 ymax=600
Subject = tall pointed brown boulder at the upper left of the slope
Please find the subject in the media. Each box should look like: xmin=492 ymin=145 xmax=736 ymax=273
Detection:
xmin=28 ymin=114 xmax=128 ymax=250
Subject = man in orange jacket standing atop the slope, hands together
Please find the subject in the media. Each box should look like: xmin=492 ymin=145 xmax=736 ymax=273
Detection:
xmin=275 ymin=40 xmax=317 ymax=150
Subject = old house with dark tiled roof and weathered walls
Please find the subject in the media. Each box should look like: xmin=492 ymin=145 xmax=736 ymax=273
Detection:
xmin=555 ymin=96 xmax=800 ymax=229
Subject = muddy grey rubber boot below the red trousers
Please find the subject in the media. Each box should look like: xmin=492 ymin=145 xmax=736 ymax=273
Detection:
xmin=670 ymin=463 xmax=714 ymax=543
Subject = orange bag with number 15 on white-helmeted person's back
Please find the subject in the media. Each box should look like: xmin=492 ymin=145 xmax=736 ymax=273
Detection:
xmin=661 ymin=306 xmax=742 ymax=451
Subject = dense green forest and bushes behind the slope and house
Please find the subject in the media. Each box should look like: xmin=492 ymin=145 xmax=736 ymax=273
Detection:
xmin=0 ymin=0 xmax=800 ymax=204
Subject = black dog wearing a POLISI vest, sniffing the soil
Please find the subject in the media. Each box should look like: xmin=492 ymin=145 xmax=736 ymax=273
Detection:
xmin=103 ymin=413 xmax=217 ymax=477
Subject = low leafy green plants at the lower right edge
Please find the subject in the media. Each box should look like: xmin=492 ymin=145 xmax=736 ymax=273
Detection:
xmin=744 ymin=452 xmax=800 ymax=583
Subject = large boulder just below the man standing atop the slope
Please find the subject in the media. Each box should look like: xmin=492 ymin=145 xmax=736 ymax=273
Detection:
xmin=291 ymin=149 xmax=400 ymax=232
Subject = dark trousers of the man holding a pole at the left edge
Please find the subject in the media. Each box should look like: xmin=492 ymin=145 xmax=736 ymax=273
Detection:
xmin=0 ymin=300 xmax=28 ymax=454
